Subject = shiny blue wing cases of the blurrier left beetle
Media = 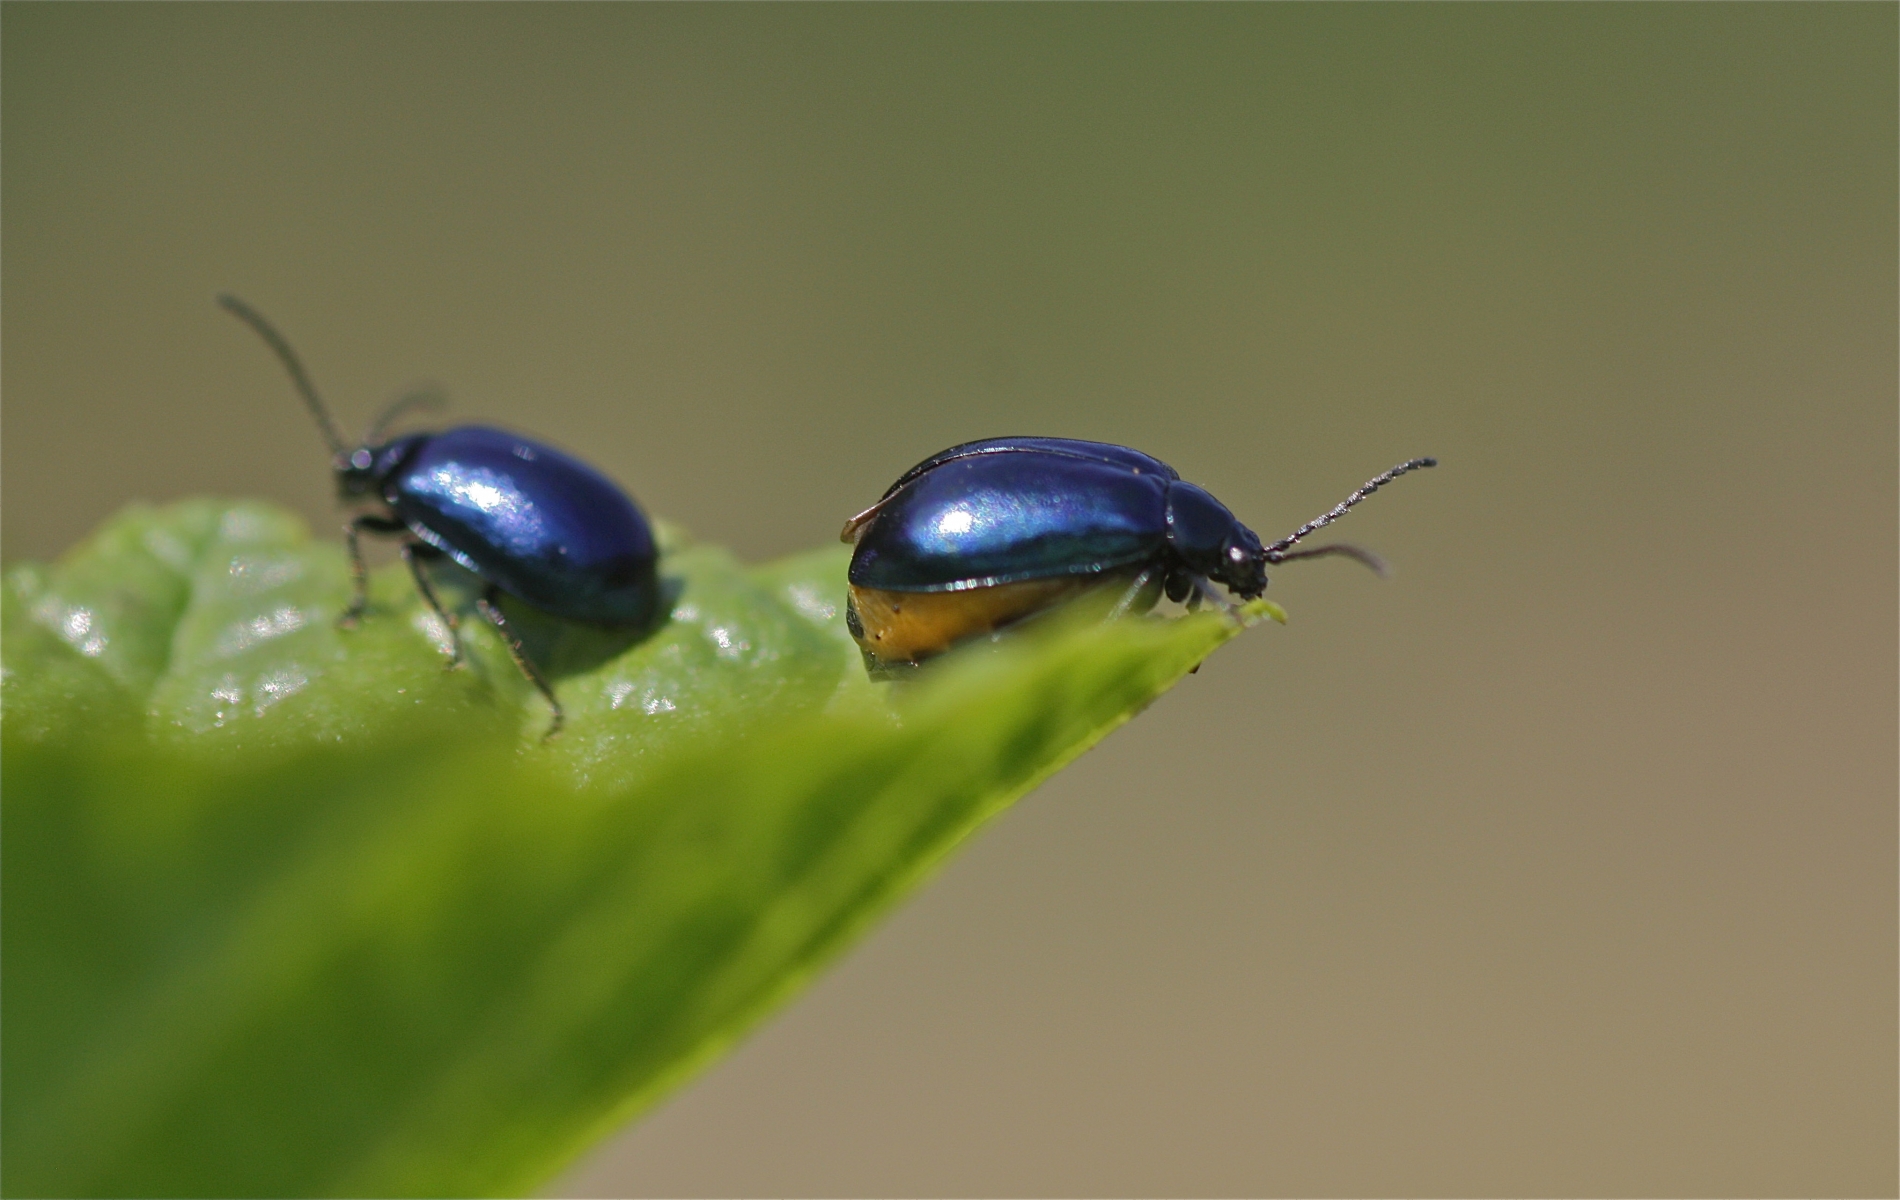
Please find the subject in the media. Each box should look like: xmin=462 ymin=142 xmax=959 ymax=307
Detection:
xmin=384 ymin=425 xmax=657 ymax=625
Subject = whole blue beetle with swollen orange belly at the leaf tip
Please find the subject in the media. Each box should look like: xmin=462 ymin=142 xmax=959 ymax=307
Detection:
xmin=840 ymin=437 xmax=1436 ymax=670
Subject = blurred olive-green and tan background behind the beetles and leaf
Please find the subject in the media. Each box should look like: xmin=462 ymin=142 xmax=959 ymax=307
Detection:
xmin=0 ymin=4 xmax=1900 ymax=1196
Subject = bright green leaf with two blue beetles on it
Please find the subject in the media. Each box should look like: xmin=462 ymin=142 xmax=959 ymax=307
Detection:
xmin=0 ymin=501 xmax=1281 ymax=1196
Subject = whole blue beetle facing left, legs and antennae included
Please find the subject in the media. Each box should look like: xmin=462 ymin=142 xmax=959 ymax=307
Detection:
xmin=219 ymin=296 xmax=659 ymax=737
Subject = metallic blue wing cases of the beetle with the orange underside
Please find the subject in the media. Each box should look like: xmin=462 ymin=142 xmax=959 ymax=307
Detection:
xmin=851 ymin=450 xmax=1169 ymax=592
